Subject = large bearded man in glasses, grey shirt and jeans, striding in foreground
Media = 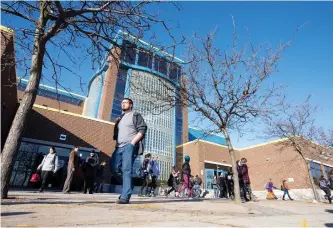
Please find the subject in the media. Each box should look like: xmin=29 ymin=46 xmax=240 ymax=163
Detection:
xmin=111 ymin=98 xmax=147 ymax=204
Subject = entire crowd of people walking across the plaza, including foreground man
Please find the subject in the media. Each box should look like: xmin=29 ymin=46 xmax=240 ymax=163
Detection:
xmin=33 ymin=98 xmax=333 ymax=204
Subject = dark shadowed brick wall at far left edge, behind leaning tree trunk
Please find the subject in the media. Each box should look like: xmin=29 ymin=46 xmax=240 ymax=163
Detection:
xmin=1 ymin=26 xmax=18 ymax=150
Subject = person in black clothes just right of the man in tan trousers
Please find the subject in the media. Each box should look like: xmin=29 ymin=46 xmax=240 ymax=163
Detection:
xmin=83 ymin=150 xmax=99 ymax=194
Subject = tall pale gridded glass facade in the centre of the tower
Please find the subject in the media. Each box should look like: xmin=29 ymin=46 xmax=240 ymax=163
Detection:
xmin=129 ymin=70 xmax=175 ymax=180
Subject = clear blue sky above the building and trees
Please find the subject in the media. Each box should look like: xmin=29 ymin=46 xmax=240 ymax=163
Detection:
xmin=2 ymin=2 xmax=333 ymax=147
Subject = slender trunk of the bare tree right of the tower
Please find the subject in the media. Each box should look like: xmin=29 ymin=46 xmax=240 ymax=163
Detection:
xmin=221 ymin=129 xmax=241 ymax=203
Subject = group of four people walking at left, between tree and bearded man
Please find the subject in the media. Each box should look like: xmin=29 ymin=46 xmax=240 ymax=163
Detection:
xmin=37 ymin=147 xmax=106 ymax=194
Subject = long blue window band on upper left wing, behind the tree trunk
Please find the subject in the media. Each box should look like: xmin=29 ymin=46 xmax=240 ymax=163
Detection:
xmin=18 ymin=83 xmax=84 ymax=106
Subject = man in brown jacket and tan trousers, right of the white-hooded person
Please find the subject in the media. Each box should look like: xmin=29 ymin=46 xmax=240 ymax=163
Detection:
xmin=62 ymin=146 xmax=80 ymax=194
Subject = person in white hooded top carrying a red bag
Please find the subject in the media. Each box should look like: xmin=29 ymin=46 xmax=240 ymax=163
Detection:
xmin=37 ymin=147 xmax=59 ymax=192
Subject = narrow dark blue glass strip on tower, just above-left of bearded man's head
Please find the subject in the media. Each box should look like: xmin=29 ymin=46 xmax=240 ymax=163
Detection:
xmin=111 ymin=68 xmax=127 ymax=121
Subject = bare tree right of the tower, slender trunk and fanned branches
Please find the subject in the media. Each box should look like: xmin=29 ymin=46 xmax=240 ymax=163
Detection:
xmin=132 ymin=17 xmax=300 ymax=203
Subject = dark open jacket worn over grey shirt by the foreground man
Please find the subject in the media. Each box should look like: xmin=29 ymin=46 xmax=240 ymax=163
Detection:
xmin=113 ymin=112 xmax=147 ymax=155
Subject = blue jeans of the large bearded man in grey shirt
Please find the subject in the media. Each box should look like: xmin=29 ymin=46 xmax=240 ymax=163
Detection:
xmin=111 ymin=144 xmax=137 ymax=200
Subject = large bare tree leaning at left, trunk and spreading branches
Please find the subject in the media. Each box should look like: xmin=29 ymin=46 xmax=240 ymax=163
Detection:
xmin=1 ymin=1 xmax=180 ymax=198
